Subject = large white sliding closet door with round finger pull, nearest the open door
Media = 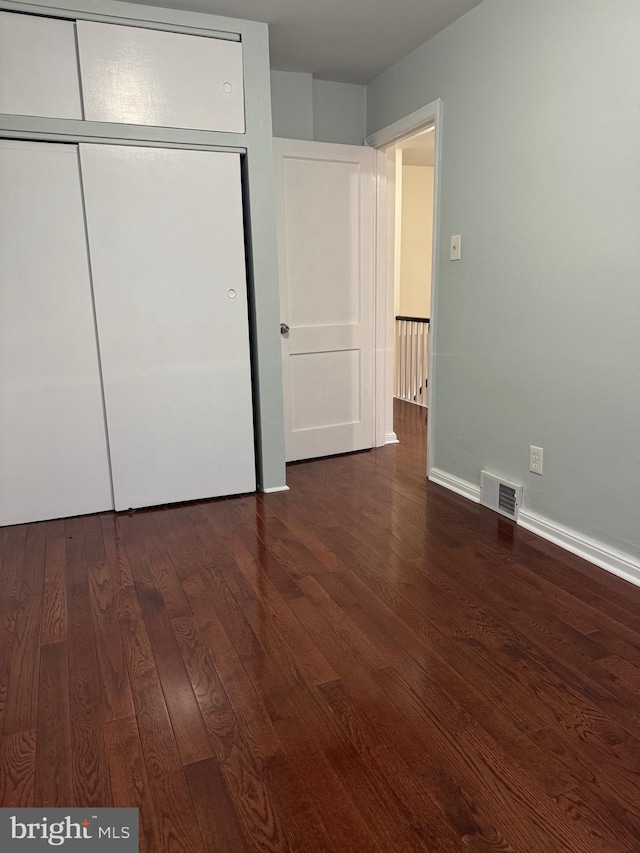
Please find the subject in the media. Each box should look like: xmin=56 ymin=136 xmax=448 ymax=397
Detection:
xmin=80 ymin=145 xmax=255 ymax=510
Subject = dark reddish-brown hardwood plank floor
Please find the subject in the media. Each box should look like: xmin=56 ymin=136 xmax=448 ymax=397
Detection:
xmin=0 ymin=403 xmax=640 ymax=853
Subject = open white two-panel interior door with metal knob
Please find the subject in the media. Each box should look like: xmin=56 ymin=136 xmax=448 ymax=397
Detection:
xmin=274 ymin=139 xmax=375 ymax=462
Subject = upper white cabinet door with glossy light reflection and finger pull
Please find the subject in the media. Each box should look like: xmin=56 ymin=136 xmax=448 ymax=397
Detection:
xmin=77 ymin=21 xmax=244 ymax=133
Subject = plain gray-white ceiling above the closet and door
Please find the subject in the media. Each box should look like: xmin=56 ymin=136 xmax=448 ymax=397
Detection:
xmin=127 ymin=0 xmax=481 ymax=83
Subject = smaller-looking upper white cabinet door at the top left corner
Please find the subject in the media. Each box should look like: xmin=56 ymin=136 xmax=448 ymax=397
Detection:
xmin=0 ymin=12 xmax=82 ymax=119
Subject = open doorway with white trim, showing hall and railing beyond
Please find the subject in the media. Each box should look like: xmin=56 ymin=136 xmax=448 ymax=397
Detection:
xmin=366 ymin=99 xmax=442 ymax=474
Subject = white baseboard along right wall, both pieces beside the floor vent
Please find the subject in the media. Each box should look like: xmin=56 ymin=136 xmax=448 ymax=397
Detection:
xmin=429 ymin=468 xmax=640 ymax=586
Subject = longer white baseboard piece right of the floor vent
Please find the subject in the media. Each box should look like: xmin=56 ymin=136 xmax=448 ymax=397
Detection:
xmin=518 ymin=509 xmax=640 ymax=586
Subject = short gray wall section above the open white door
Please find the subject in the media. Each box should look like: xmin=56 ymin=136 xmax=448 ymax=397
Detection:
xmin=271 ymin=71 xmax=367 ymax=145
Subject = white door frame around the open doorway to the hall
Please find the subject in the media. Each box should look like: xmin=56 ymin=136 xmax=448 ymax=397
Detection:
xmin=365 ymin=98 xmax=443 ymax=476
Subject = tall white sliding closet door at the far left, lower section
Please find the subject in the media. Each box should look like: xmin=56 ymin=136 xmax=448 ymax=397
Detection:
xmin=0 ymin=141 xmax=113 ymax=524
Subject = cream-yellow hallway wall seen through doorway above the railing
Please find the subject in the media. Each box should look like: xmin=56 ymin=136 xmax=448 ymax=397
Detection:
xmin=399 ymin=164 xmax=433 ymax=317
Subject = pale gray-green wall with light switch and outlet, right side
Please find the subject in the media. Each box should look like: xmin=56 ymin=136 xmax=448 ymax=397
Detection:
xmin=367 ymin=0 xmax=640 ymax=558
